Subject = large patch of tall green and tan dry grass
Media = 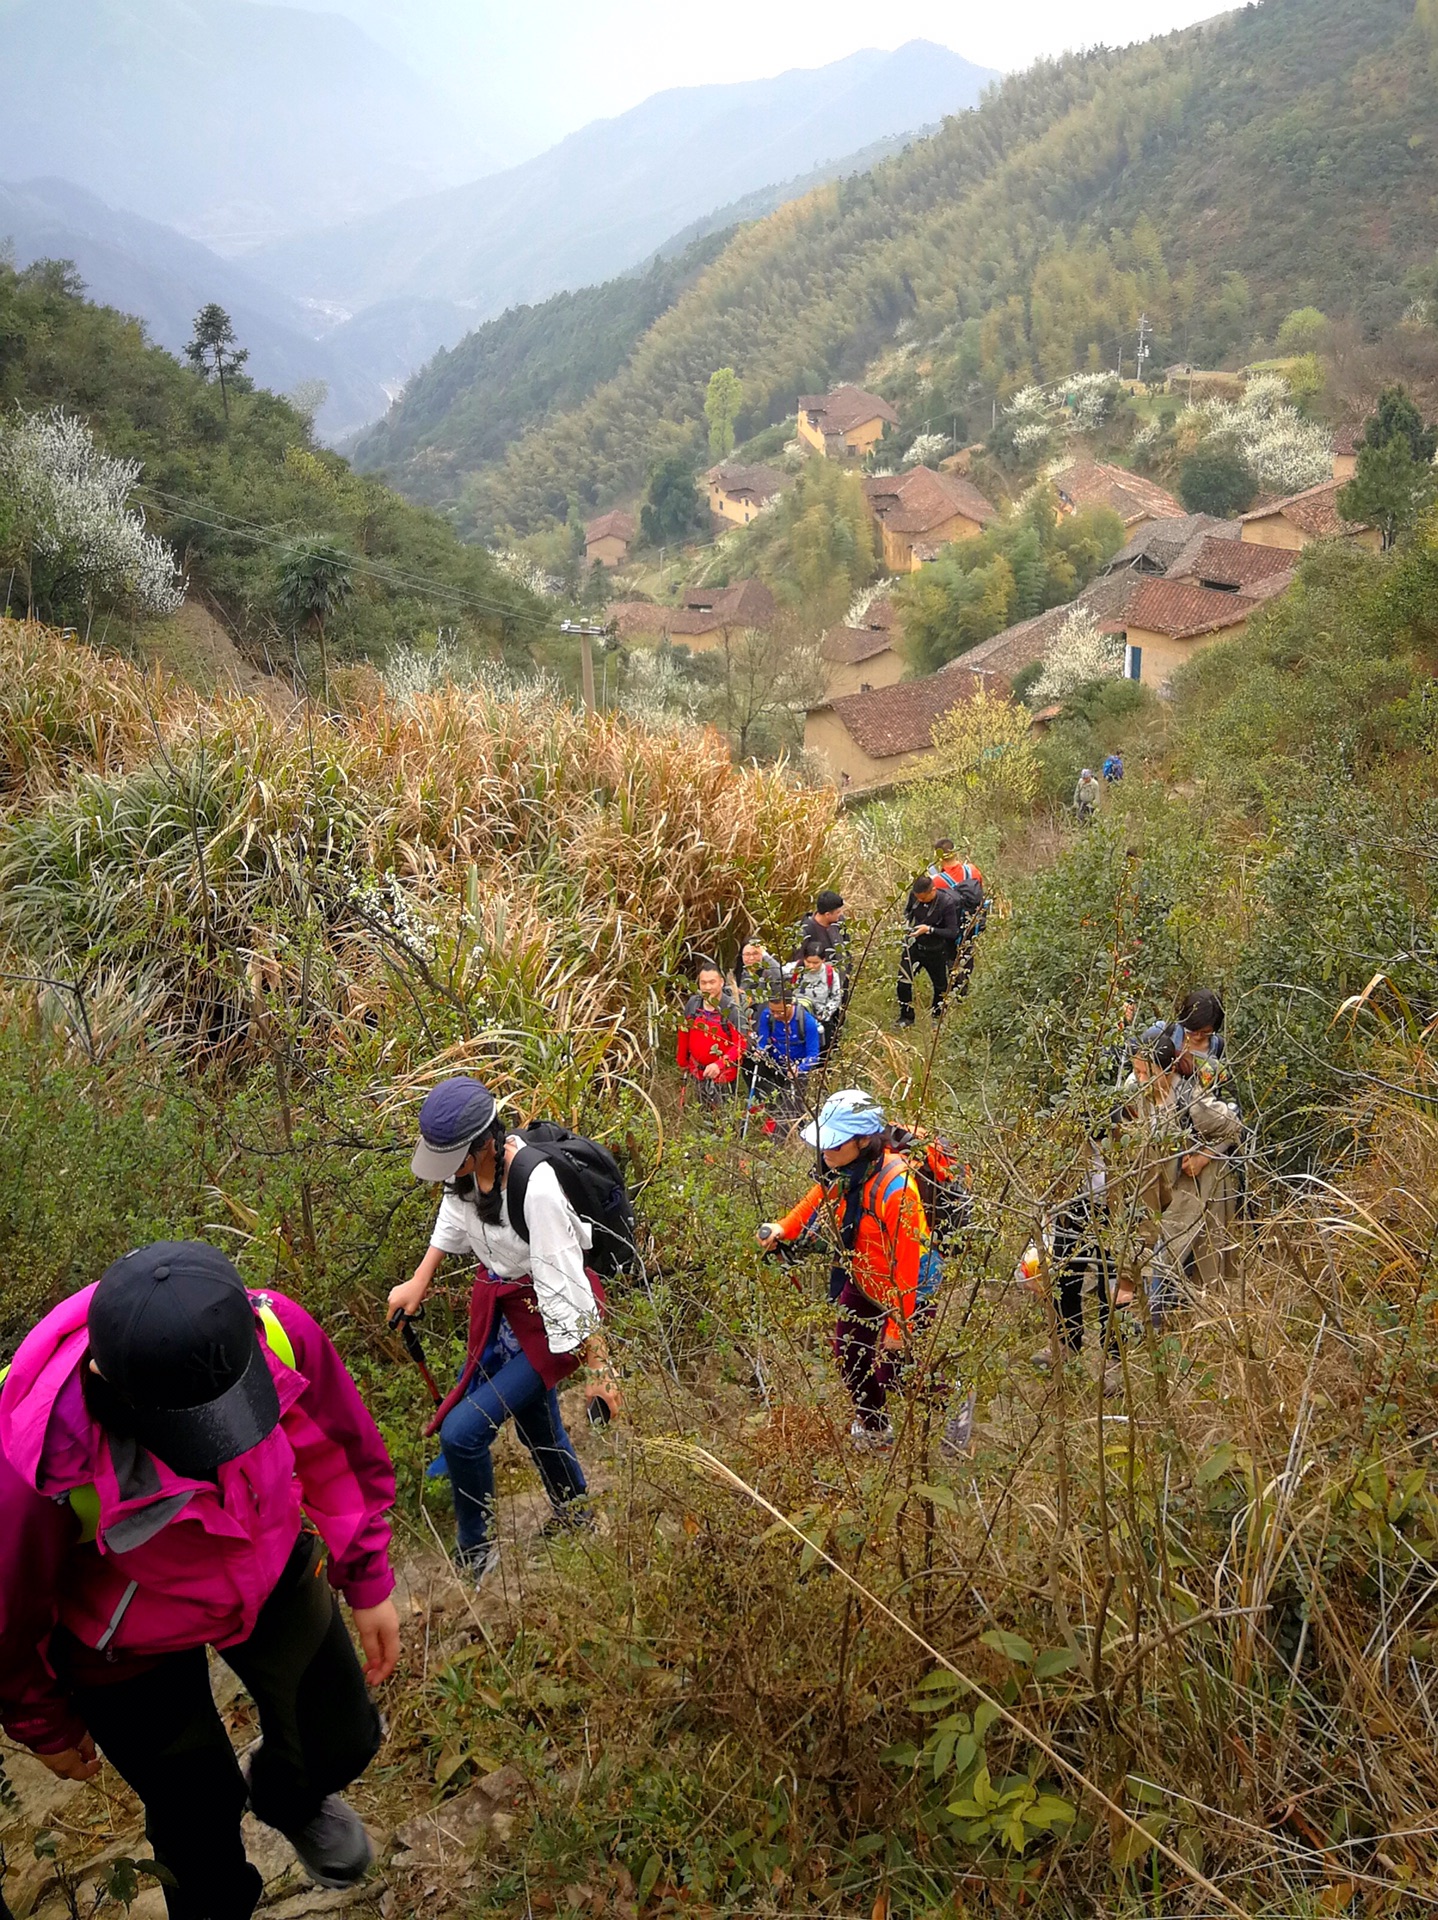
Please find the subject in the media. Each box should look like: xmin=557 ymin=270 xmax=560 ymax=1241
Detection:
xmin=0 ymin=622 xmax=831 ymax=1079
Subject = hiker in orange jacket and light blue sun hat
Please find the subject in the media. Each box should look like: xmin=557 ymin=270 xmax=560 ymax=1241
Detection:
xmin=758 ymin=1087 xmax=968 ymax=1453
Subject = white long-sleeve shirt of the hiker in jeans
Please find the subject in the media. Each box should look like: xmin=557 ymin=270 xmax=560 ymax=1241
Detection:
xmin=430 ymin=1135 xmax=599 ymax=1354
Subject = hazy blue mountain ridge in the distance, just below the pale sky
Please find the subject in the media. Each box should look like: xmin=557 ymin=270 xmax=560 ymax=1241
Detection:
xmin=252 ymin=40 xmax=996 ymax=321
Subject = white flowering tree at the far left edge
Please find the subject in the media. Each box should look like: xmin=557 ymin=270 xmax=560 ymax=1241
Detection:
xmin=0 ymin=407 xmax=184 ymax=618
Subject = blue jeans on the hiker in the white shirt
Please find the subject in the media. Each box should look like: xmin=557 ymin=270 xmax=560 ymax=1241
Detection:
xmin=440 ymin=1354 xmax=587 ymax=1561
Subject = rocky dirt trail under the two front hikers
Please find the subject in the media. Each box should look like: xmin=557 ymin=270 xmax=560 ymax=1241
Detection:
xmin=0 ymin=1390 xmax=616 ymax=1920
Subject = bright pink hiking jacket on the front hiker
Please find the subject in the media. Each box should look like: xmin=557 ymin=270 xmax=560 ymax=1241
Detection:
xmin=0 ymin=1286 xmax=394 ymax=1753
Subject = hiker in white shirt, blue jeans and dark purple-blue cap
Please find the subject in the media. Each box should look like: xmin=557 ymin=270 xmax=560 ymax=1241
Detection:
xmin=390 ymin=1079 xmax=603 ymax=1580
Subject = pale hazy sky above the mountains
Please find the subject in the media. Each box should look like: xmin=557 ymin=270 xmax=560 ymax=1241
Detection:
xmin=316 ymin=0 xmax=1219 ymax=150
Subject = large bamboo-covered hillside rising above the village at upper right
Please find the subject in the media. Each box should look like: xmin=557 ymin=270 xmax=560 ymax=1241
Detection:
xmin=408 ymin=0 xmax=1438 ymax=534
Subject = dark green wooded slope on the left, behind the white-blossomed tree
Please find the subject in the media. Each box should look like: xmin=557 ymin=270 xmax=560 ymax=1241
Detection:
xmin=0 ymin=263 xmax=547 ymax=662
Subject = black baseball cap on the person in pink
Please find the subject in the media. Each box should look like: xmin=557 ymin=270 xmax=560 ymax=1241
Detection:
xmin=88 ymin=1240 xmax=280 ymax=1478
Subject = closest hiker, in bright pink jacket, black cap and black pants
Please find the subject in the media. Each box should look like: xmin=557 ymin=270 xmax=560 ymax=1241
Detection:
xmin=0 ymin=1240 xmax=399 ymax=1920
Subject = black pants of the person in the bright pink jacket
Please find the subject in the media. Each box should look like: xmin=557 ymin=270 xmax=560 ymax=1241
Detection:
xmin=52 ymin=1532 xmax=380 ymax=1920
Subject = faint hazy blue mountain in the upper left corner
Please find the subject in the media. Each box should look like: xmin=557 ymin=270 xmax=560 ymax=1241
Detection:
xmin=0 ymin=0 xmax=501 ymax=253
